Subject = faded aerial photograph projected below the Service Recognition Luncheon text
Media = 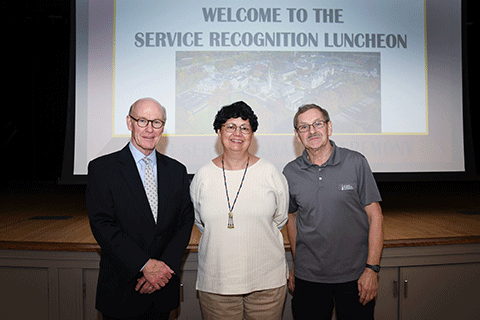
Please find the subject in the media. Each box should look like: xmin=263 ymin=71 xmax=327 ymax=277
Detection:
xmin=175 ymin=51 xmax=381 ymax=135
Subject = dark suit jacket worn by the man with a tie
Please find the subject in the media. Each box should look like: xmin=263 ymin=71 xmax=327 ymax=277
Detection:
xmin=86 ymin=145 xmax=193 ymax=318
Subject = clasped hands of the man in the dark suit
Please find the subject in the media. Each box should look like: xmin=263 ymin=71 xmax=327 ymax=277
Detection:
xmin=139 ymin=259 xmax=175 ymax=293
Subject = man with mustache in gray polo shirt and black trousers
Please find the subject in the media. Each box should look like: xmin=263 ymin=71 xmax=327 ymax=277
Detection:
xmin=283 ymin=104 xmax=383 ymax=320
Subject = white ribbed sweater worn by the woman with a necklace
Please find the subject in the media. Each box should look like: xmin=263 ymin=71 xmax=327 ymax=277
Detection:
xmin=190 ymin=159 xmax=288 ymax=294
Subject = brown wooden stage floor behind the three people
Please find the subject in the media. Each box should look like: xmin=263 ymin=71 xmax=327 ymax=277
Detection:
xmin=0 ymin=184 xmax=480 ymax=251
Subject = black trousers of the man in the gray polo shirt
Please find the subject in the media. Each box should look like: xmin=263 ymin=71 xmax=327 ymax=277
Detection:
xmin=292 ymin=277 xmax=375 ymax=320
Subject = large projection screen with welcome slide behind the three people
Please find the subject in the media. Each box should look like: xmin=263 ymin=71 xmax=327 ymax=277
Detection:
xmin=73 ymin=0 xmax=465 ymax=175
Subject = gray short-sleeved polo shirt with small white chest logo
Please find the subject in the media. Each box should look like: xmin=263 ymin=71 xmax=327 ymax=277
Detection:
xmin=283 ymin=141 xmax=382 ymax=283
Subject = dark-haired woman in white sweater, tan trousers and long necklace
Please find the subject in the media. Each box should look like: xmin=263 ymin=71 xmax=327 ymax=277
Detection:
xmin=190 ymin=101 xmax=288 ymax=320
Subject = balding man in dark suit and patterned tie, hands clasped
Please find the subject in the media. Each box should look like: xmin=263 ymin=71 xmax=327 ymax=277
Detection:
xmin=86 ymin=98 xmax=193 ymax=319
